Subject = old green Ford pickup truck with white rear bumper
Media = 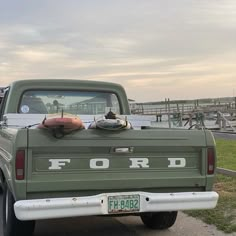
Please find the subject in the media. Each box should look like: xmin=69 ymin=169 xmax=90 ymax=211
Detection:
xmin=0 ymin=80 xmax=218 ymax=236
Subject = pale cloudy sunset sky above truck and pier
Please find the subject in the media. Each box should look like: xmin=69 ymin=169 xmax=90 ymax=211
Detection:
xmin=0 ymin=0 xmax=236 ymax=102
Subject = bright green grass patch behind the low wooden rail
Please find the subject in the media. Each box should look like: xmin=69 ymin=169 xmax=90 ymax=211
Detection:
xmin=216 ymin=139 xmax=236 ymax=171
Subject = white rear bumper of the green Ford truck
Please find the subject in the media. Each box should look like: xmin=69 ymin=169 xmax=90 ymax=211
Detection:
xmin=14 ymin=191 xmax=219 ymax=220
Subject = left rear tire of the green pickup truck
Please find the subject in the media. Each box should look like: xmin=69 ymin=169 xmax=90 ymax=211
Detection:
xmin=1 ymin=182 xmax=35 ymax=236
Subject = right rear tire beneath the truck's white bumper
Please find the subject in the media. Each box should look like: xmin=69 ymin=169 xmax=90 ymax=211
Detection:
xmin=140 ymin=211 xmax=178 ymax=229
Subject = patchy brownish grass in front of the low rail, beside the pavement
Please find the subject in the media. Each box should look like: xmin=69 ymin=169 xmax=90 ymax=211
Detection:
xmin=185 ymin=175 xmax=236 ymax=233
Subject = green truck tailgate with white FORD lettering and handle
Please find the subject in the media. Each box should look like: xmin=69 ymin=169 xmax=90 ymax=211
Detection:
xmin=27 ymin=129 xmax=207 ymax=198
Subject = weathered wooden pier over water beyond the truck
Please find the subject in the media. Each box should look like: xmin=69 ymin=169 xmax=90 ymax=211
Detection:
xmin=131 ymin=97 xmax=236 ymax=132
